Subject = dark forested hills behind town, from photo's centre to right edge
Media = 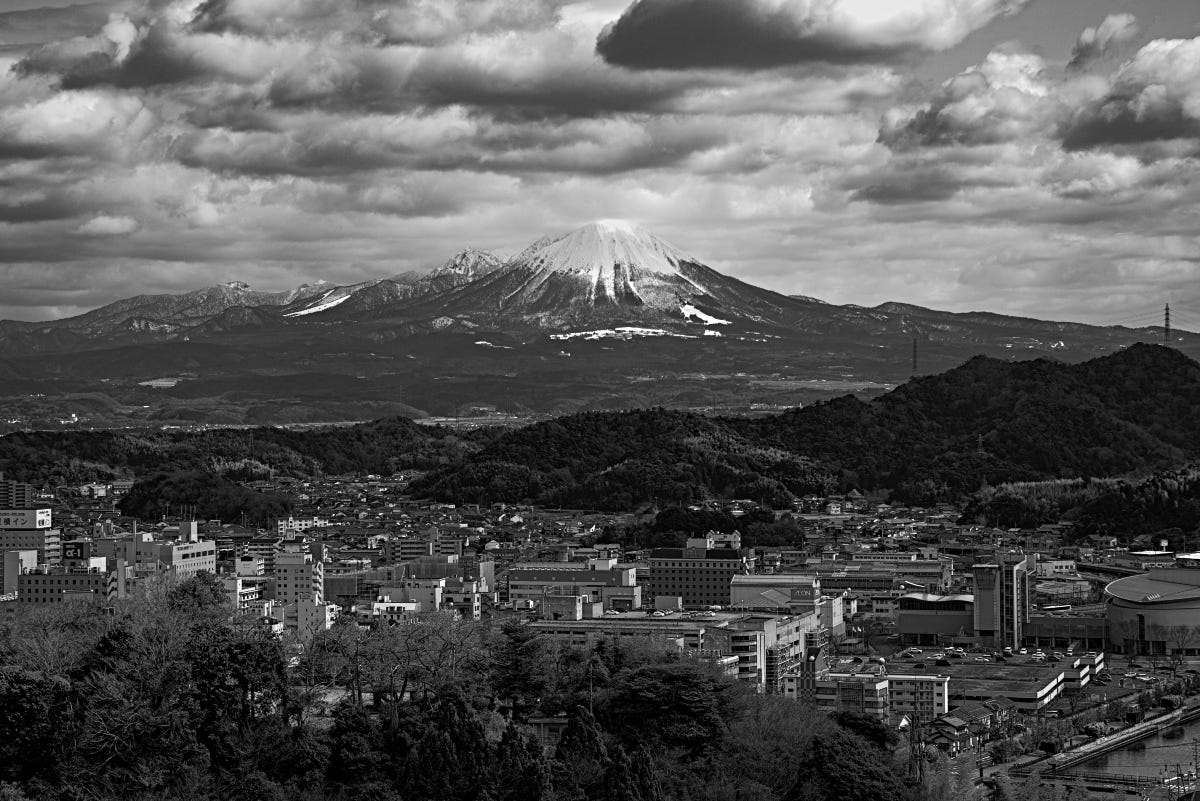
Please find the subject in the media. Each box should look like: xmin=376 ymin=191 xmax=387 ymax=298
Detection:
xmin=420 ymin=345 xmax=1200 ymax=508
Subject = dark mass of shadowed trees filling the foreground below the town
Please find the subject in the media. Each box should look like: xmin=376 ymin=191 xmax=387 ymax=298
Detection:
xmin=0 ymin=574 xmax=970 ymax=801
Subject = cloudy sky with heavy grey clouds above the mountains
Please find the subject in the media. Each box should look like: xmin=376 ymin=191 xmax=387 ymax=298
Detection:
xmin=0 ymin=0 xmax=1200 ymax=323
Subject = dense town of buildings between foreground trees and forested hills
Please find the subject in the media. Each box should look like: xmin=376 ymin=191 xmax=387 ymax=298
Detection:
xmin=14 ymin=476 xmax=1200 ymax=747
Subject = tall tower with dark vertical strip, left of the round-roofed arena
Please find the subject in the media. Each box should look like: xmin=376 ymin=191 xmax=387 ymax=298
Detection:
xmin=971 ymin=550 xmax=1031 ymax=649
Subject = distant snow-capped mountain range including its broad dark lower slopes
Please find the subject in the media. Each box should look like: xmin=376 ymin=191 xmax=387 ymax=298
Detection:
xmin=0 ymin=222 xmax=1200 ymax=430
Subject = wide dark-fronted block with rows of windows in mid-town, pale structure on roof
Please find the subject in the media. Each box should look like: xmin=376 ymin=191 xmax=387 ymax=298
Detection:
xmin=647 ymin=537 xmax=754 ymax=608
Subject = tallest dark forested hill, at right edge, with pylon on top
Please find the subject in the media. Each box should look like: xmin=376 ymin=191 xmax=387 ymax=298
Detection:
xmin=738 ymin=345 xmax=1200 ymax=500
